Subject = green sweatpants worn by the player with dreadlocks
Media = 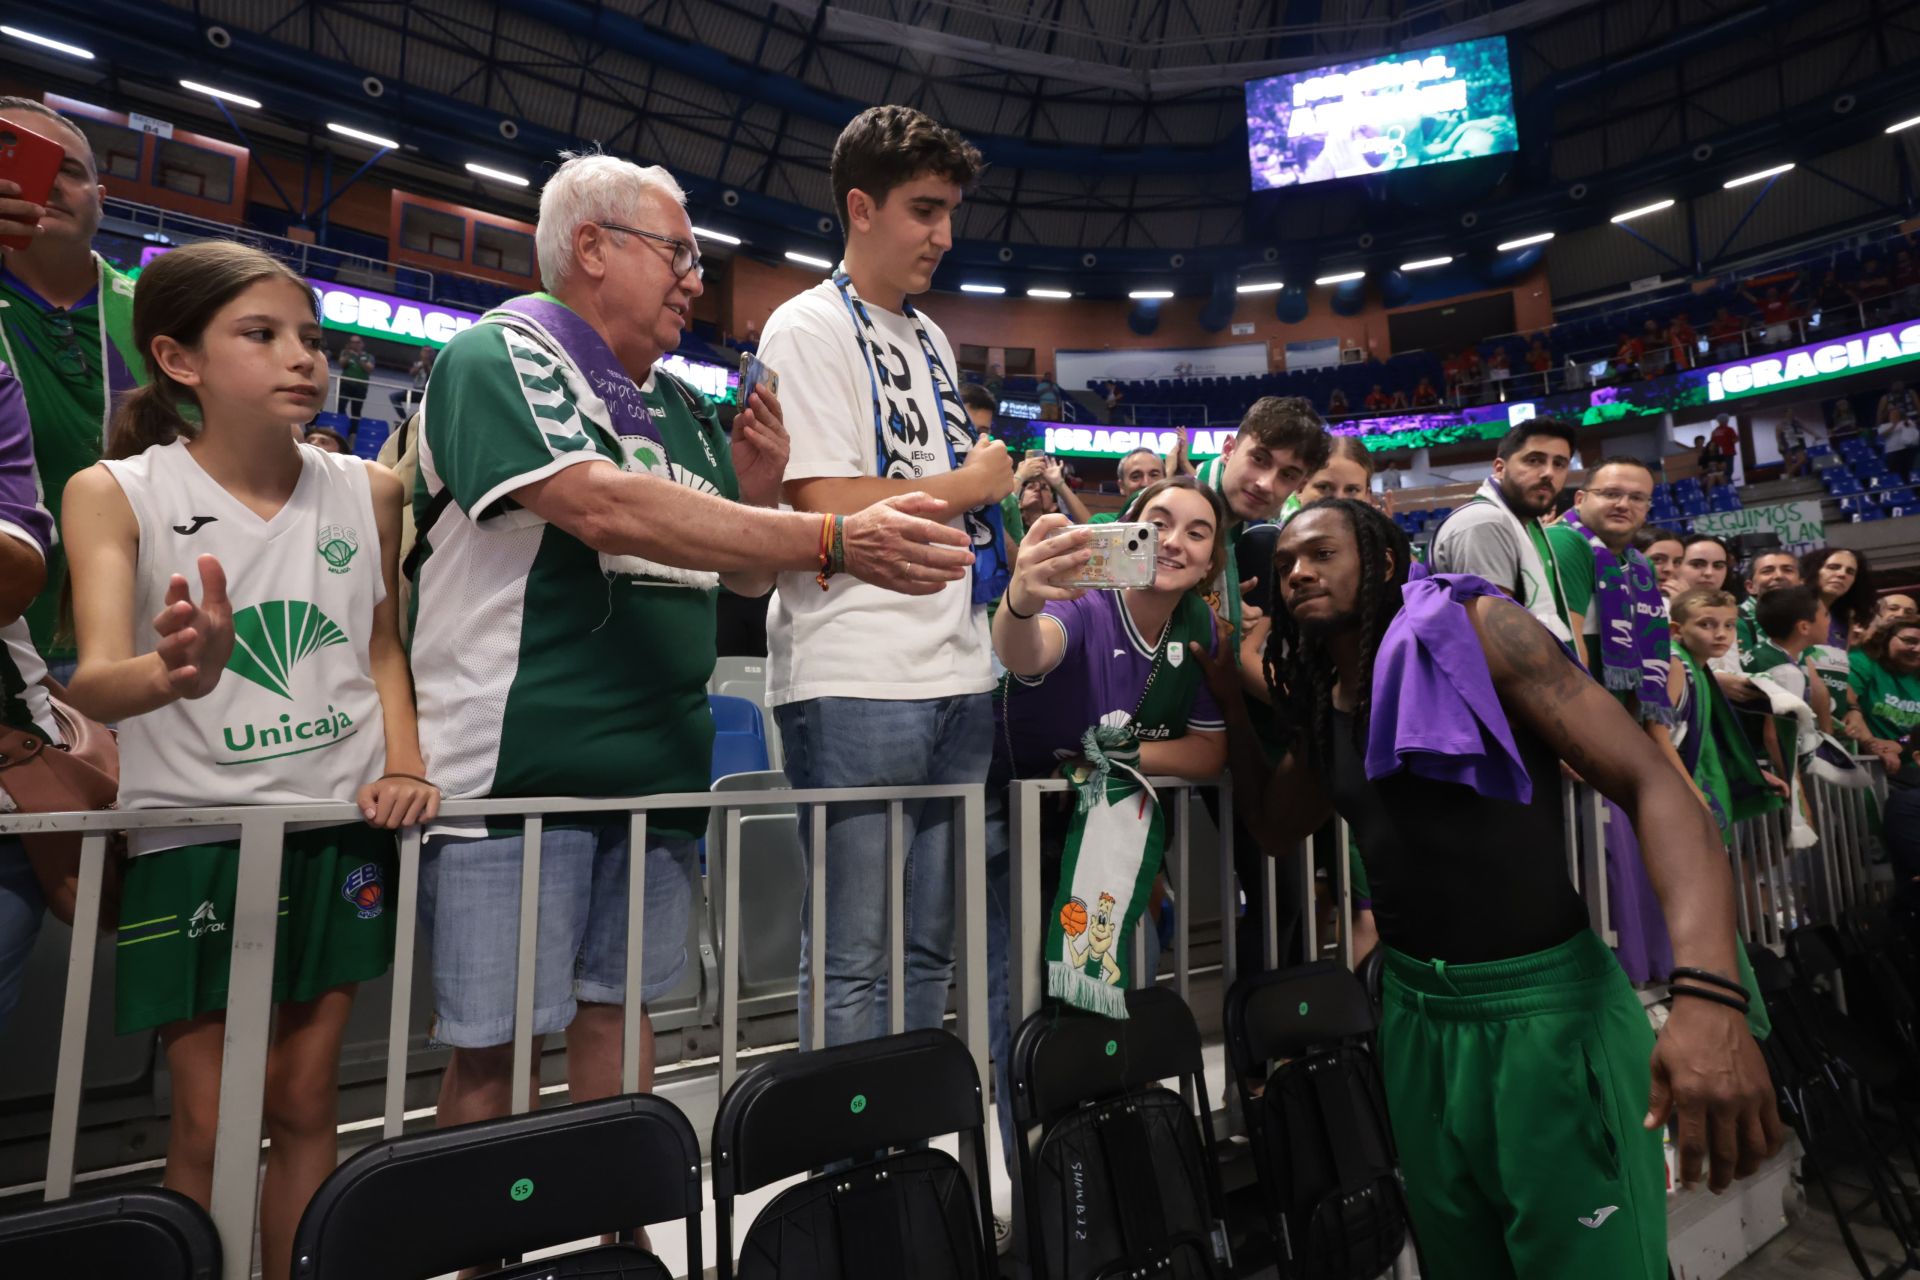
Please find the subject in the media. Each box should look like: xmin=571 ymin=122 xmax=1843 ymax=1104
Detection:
xmin=1380 ymin=929 xmax=1667 ymax=1280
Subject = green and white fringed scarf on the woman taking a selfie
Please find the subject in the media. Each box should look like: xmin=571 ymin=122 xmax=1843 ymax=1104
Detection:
xmin=1044 ymin=593 xmax=1225 ymax=1017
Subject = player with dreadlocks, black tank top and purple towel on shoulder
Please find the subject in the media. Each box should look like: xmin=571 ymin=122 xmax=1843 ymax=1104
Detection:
xmin=1194 ymin=499 xmax=1780 ymax=1280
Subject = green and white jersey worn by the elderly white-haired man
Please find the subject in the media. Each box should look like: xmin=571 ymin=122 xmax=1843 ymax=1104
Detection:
xmin=413 ymin=305 xmax=739 ymax=835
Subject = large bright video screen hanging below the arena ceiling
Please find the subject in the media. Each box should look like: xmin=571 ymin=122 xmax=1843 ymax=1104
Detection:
xmin=1246 ymin=36 xmax=1519 ymax=192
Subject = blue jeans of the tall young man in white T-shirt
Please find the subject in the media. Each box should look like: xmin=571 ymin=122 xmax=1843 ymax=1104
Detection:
xmin=774 ymin=693 xmax=993 ymax=1048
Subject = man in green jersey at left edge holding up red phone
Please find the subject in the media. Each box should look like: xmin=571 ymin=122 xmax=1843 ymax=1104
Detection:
xmin=0 ymin=98 xmax=146 ymax=679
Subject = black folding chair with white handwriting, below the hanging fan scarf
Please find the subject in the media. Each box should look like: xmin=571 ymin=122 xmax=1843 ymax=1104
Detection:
xmin=1008 ymin=986 xmax=1233 ymax=1280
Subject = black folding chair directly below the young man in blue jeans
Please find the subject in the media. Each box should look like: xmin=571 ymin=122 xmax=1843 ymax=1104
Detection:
xmin=710 ymin=1031 xmax=995 ymax=1280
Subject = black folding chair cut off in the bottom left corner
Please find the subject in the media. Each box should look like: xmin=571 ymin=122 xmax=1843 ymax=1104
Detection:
xmin=0 ymin=1190 xmax=221 ymax=1280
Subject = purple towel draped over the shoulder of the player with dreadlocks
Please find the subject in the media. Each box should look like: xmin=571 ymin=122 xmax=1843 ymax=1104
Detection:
xmin=1367 ymin=574 xmax=1534 ymax=804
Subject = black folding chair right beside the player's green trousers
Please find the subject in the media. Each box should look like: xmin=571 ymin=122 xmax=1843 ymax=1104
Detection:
xmin=1227 ymin=960 xmax=1409 ymax=1280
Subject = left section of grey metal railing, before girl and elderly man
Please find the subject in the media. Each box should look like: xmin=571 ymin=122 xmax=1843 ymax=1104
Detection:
xmin=18 ymin=785 xmax=989 ymax=1280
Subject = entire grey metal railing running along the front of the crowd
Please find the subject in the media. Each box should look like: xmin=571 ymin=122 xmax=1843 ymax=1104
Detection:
xmin=15 ymin=762 xmax=1891 ymax=1280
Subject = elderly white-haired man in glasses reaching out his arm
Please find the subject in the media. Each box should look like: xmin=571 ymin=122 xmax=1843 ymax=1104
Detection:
xmin=409 ymin=155 xmax=972 ymax=1125
